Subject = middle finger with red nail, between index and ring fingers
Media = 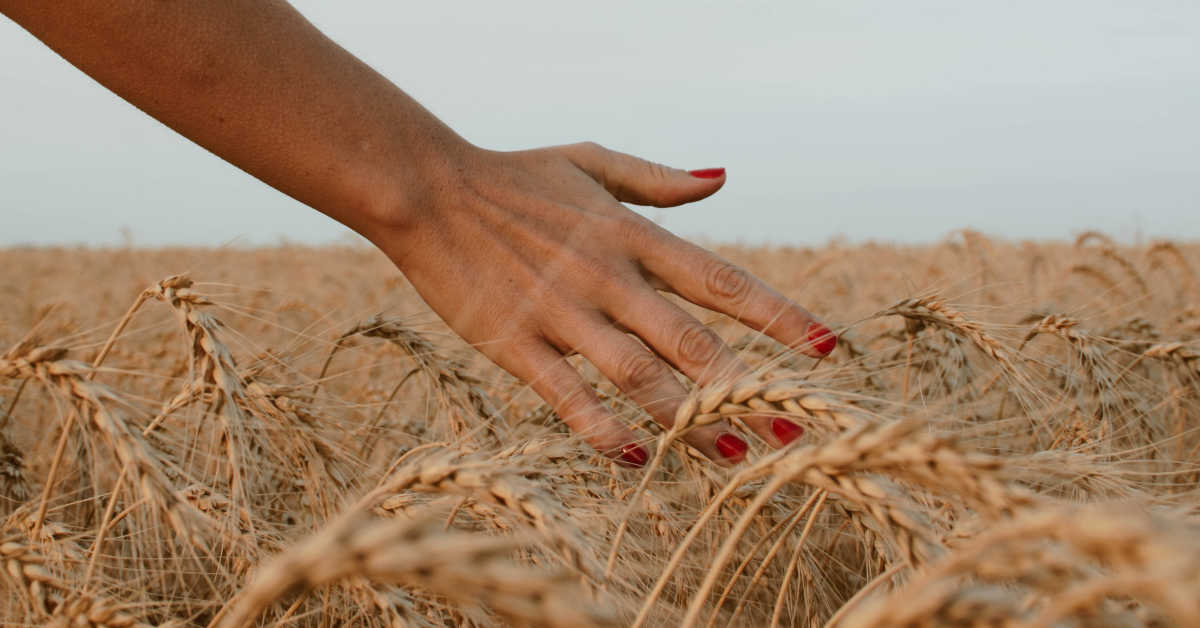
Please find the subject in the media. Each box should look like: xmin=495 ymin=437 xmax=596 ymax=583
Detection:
xmin=609 ymin=289 xmax=803 ymax=457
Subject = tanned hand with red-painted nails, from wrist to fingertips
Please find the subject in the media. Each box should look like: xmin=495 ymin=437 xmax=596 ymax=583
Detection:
xmin=371 ymin=143 xmax=836 ymax=466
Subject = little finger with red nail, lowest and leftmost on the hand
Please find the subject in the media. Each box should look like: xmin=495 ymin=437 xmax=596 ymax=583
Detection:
xmin=505 ymin=341 xmax=649 ymax=467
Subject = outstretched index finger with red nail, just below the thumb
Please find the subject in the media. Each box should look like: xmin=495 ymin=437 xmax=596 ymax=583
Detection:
xmin=640 ymin=229 xmax=838 ymax=358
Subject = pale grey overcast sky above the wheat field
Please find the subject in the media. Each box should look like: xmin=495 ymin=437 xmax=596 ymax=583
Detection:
xmin=0 ymin=0 xmax=1200 ymax=246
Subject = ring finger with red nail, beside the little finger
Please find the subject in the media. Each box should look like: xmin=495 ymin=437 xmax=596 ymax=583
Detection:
xmin=571 ymin=313 xmax=748 ymax=466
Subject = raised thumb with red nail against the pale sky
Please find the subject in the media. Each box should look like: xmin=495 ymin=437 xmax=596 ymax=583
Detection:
xmin=562 ymin=142 xmax=725 ymax=208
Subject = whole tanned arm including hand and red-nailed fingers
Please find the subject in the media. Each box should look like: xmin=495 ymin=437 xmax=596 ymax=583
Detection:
xmin=0 ymin=0 xmax=836 ymax=465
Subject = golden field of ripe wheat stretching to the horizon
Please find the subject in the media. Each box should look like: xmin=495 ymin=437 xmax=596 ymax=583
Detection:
xmin=0 ymin=232 xmax=1200 ymax=628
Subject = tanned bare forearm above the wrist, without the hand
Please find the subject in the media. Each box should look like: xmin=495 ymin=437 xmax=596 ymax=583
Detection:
xmin=0 ymin=0 xmax=469 ymax=237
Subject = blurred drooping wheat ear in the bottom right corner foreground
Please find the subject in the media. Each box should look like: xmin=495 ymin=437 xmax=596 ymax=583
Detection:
xmin=845 ymin=504 xmax=1200 ymax=628
